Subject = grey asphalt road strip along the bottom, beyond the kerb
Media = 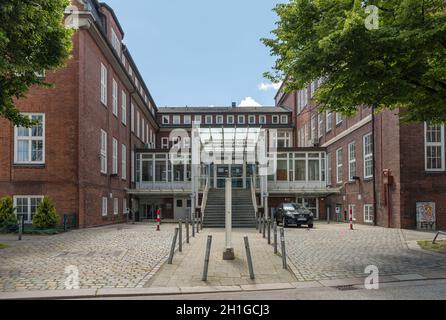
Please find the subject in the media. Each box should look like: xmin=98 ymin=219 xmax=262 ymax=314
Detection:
xmin=84 ymin=279 xmax=446 ymax=300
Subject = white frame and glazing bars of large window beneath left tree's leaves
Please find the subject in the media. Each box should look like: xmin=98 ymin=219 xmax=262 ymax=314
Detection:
xmin=14 ymin=113 xmax=46 ymax=165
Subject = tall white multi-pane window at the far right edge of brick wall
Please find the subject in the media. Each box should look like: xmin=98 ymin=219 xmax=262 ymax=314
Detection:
xmin=424 ymin=123 xmax=445 ymax=171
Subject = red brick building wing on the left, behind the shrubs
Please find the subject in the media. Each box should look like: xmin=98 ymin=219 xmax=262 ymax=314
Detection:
xmin=0 ymin=1 xmax=158 ymax=227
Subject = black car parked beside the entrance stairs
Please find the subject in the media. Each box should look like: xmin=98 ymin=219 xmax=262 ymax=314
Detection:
xmin=276 ymin=202 xmax=314 ymax=229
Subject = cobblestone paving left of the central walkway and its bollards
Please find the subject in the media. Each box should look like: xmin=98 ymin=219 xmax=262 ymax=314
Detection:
xmin=0 ymin=224 xmax=174 ymax=292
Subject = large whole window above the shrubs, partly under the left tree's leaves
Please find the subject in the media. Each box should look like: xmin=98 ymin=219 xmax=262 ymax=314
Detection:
xmin=14 ymin=114 xmax=45 ymax=164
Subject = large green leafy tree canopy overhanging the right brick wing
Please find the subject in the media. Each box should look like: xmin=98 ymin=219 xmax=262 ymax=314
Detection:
xmin=262 ymin=0 xmax=446 ymax=122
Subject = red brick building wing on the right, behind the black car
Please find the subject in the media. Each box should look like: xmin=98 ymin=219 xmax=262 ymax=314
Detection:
xmin=276 ymin=81 xmax=446 ymax=229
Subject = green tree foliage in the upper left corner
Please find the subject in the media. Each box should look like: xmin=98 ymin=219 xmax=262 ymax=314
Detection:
xmin=0 ymin=0 xmax=72 ymax=127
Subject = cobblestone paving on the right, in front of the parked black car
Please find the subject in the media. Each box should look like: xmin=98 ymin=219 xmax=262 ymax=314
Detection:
xmin=285 ymin=223 xmax=446 ymax=281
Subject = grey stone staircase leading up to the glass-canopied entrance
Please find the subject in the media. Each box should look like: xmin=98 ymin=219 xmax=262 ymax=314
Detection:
xmin=203 ymin=189 xmax=256 ymax=228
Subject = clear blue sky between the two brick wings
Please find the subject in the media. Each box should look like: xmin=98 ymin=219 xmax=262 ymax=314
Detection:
xmin=104 ymin=0 xmax=285 ymax=107
